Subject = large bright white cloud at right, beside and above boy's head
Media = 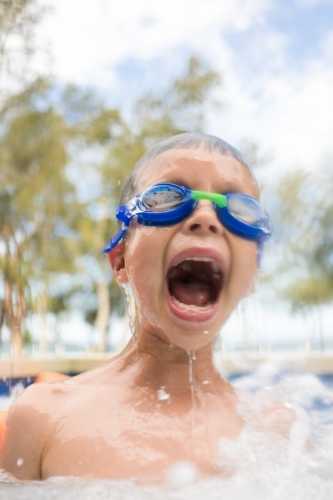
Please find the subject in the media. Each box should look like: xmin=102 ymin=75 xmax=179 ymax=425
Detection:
xmin=206 ymin=21 xmax=333 ymax=172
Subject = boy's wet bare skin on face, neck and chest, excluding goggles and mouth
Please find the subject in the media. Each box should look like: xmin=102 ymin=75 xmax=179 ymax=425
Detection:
xmin=1 ymin=149 xmax=264 ymax=481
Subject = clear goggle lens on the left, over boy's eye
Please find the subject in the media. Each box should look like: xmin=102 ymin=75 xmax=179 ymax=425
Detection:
xmin=141 ymin=186 xmax=186 ymax=212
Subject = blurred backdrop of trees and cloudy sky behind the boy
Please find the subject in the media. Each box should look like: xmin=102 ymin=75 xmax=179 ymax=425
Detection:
xmin=0 ymin=0 xmax=333 ymax=357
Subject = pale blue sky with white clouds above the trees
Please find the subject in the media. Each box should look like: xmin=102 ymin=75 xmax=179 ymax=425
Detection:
xmin=26 ymin=0 xmax=333 ymax=352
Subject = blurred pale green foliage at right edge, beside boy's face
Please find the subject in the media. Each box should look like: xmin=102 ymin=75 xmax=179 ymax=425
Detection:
xmin=268 ymin=169 xmax=333 ymax=310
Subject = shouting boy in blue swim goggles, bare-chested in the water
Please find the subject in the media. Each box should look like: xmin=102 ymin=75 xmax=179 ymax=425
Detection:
xmin=1 ymin=134 xmax=286 ymax=481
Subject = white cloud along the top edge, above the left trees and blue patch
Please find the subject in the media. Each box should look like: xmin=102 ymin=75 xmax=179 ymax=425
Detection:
xmin=38 ymin=0 xmax=270 ymax=85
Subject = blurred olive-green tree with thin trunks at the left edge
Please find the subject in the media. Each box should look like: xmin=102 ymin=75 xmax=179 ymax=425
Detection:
xmin=0 ymin=80 xmax=76 ymax=355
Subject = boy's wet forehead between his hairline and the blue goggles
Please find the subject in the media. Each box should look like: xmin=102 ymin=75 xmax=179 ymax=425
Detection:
xmin=136 ymin=148 xmax=258 ymax=195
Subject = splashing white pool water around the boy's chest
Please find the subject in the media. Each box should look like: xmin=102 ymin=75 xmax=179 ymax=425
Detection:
xmin=0 ymin=363 xmax=333 ymax=500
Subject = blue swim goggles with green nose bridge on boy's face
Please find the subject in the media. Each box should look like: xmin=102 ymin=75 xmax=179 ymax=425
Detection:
xmin=103 ymin=183 xmax=272 ymax=253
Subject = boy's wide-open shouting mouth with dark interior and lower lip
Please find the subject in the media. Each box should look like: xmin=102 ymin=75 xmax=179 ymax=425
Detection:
xmin=166 ymin=257 xmax=223 ymax=321
